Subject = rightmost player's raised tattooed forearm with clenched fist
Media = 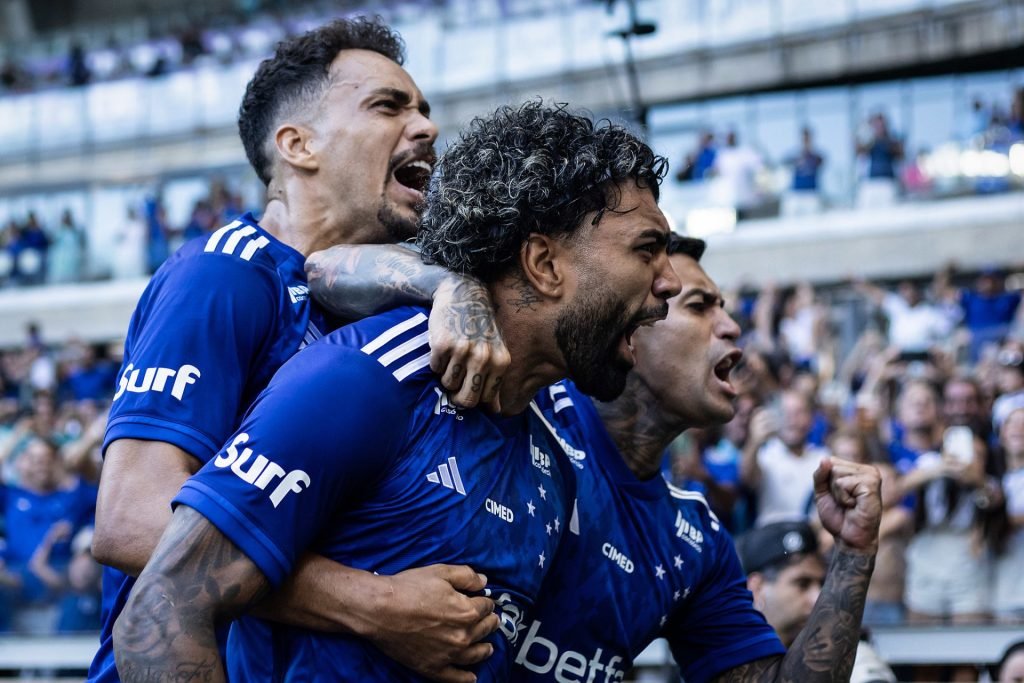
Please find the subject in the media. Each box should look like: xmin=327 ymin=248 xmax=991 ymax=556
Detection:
xmin=716 ymin=458 xmax=882 ymax=683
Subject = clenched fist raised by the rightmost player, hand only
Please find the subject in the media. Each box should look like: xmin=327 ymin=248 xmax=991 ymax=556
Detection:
xmin=814 ymin=458 xmax=882 ymax=554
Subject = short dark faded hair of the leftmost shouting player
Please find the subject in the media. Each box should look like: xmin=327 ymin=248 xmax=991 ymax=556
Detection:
xmin=239 ymin=16 xmax=406 ymax=185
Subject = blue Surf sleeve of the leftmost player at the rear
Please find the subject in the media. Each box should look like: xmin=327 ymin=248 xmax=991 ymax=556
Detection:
xmin=103 ymin=254 xmax=280 ymax=463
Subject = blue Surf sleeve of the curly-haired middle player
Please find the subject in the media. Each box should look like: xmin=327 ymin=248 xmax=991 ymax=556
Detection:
xmin=174 ymin=343 xmax=411 ymax=586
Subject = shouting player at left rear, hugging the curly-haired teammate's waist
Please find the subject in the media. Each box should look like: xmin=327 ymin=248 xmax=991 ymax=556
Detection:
xmin=89 ymin=19 xmax=507 ymax=682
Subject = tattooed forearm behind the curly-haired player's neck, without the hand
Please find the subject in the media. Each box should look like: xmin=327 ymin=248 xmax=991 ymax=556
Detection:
xmin=306 ymin=245 xmax=452 ymax=318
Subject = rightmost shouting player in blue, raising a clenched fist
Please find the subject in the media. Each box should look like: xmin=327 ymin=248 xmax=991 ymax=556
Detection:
xmin=513 ymin=237 xmax=882 ymax=683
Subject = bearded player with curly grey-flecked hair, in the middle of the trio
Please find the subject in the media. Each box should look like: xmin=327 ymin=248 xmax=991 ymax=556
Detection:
xmin=114 ymin=102 xmax=679 ymax=681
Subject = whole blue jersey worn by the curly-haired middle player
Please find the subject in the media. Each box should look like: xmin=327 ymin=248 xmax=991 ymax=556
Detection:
xmin=175 ymin=307 xmax=573 ymax=681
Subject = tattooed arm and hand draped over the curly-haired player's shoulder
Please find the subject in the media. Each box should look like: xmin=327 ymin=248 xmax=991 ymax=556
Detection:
xmin=306 ymin=245 xmax=511 ymax=409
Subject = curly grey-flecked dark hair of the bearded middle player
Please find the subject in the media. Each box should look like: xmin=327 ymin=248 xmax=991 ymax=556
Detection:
xmin=418 ymin=100 xmax=668 ymax=282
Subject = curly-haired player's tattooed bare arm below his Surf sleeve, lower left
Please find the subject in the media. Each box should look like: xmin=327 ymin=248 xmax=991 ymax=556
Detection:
xmin=114 ymin=506 xmax=269 ymax=683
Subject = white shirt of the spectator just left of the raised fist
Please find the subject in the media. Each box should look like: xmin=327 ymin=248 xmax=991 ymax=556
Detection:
xmin=757 ymin=436 xmax=828 ymax=526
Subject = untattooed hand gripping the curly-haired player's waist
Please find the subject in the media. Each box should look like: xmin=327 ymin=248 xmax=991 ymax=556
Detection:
xmin=367 ymin=564 xmax=498 ymax=683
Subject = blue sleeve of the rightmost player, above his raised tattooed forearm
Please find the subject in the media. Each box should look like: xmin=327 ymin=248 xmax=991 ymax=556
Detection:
xmin=665 ymin=531 xmax=785 ymax=683
